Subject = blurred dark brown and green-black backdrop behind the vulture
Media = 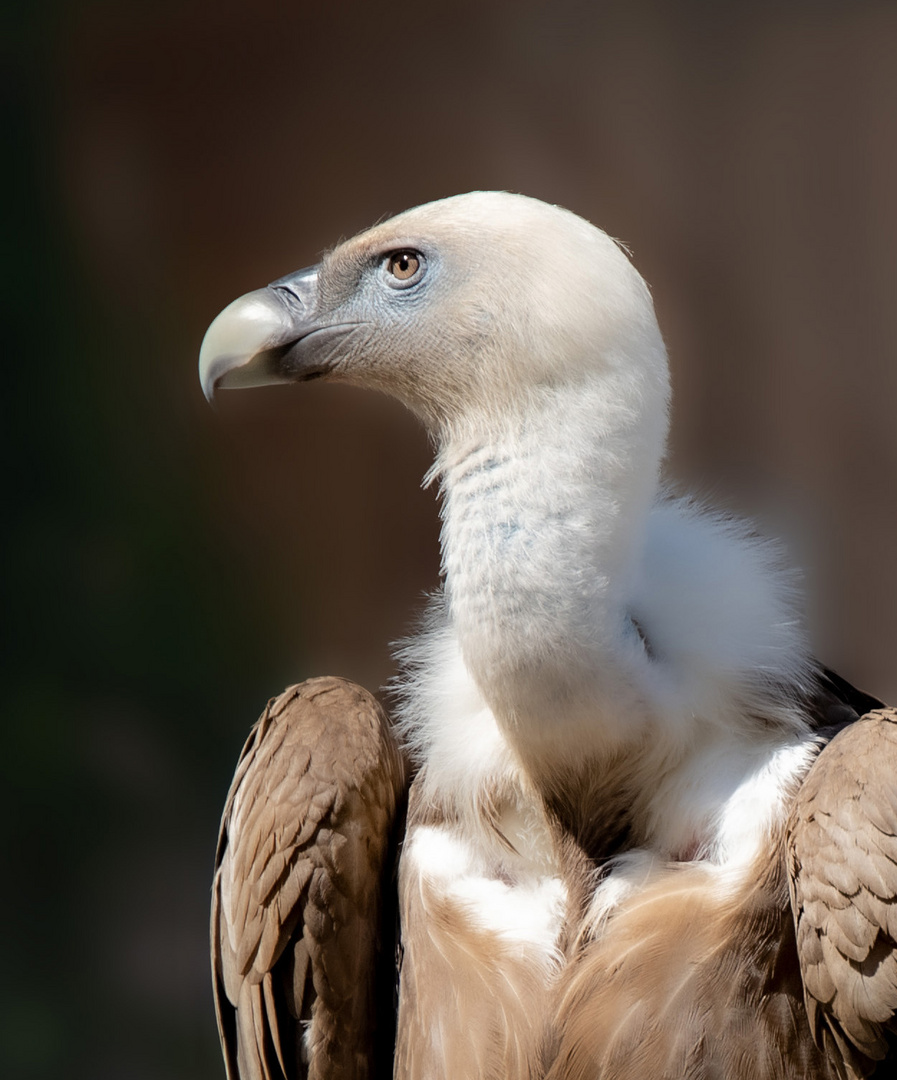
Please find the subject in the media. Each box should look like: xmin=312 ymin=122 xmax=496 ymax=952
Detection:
xmin=7 ymin=0 xmax=897 ymax=1080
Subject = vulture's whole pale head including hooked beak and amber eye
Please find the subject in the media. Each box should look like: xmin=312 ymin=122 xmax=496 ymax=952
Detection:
xmin=200 ymin=192 xmax=668 ymax=438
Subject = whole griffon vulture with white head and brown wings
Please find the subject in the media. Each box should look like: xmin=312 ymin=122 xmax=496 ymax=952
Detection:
xmin=201 ymin=192 xmax=897 ymax=1080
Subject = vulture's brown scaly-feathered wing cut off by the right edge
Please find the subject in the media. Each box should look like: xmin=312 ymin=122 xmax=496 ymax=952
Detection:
xmin=788 ymin=708 xmax=897 ymax=1076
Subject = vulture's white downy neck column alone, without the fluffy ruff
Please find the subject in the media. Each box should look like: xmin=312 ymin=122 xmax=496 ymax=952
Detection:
xmin=437 ymin=379 xmax=666 ymax=753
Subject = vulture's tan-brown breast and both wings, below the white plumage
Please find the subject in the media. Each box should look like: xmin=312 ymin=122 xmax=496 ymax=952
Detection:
xmin=213 ymin=679 xmax=897 ymax=1080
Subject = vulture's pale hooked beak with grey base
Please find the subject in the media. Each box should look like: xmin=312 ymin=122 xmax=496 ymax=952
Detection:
xmin=200 ymin=266 xmax=341 ymax=402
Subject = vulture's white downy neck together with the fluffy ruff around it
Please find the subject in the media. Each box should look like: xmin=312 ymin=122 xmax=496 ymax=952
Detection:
xmin=400 ymin=391 xmax=812 ymax=862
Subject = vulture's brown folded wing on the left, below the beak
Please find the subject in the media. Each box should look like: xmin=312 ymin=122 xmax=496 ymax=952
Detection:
xmin=212 ymin=678 xmax=406 ymax=1080
